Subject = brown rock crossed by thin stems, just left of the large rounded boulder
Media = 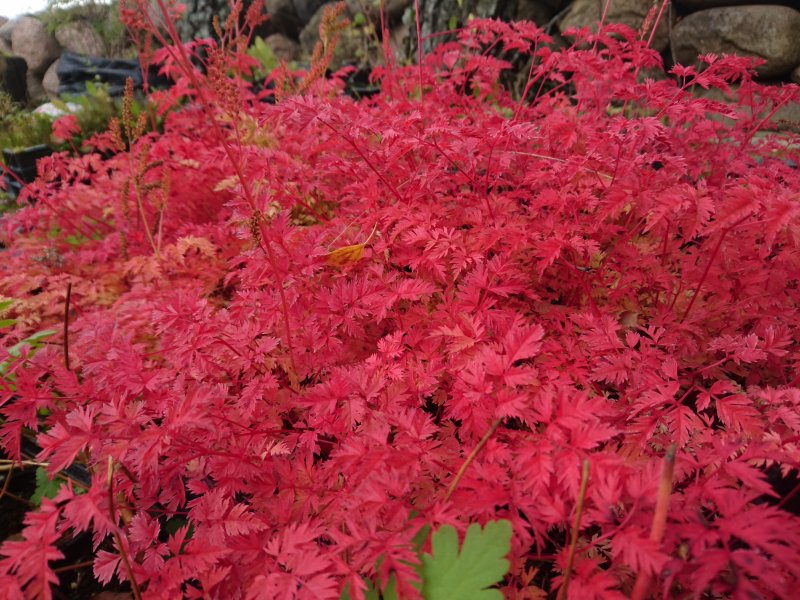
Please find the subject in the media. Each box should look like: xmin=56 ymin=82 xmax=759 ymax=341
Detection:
xmin=559 ymin=0 xmax=669 ymax=52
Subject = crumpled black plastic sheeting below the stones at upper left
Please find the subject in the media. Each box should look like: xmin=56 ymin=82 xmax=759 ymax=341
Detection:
xmin=56 ymin=50 xmax=169 ymax=96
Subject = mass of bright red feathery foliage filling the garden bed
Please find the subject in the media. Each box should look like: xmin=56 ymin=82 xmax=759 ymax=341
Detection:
xmin=0 ymin=2 xmax=800 ymax=600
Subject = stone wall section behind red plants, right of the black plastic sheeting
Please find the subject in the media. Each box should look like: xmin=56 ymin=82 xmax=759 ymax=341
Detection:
xmin=183 ymin=0 xmax=800 ymax=83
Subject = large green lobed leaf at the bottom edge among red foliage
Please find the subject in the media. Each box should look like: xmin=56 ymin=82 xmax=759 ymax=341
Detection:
xmin=422 ymin=519 xmax=511 ymax=600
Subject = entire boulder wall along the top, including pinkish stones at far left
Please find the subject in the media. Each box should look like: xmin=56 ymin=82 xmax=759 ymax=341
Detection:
xmin=0 ymin=0 xmax=800 ymax=102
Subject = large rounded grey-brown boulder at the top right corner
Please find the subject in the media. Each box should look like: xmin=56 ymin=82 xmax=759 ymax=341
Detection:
xmin=672 ymin=5 xmax=800 ymax=78
